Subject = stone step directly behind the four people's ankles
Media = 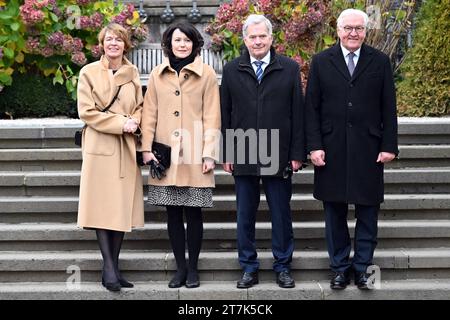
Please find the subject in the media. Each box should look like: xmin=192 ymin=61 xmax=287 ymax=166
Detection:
xmin=0 ymin=248 xmax=450 ymax=283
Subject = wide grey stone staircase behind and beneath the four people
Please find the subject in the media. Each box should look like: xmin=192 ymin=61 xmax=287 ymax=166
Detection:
xmin=0 ymin=118 xmax=450 ymax=300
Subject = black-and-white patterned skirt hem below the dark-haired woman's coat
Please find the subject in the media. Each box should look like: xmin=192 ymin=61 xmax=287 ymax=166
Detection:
xmin=147 ymin=185 xmax=213 ymax=208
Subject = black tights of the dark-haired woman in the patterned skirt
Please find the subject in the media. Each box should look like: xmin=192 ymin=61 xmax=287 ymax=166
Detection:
xmin=166 ymin=206 xmax=203 ymax=280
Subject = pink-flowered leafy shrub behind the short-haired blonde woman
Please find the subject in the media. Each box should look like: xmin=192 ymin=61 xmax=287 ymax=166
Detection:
xmin=0 ymin=0 xmax=148 ymax=99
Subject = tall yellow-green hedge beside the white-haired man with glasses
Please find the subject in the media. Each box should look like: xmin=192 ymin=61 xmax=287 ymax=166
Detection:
xmin=397 ymin=0 xmax=450 ymax=116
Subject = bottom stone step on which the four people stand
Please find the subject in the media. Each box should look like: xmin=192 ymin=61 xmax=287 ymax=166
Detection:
xmin=0 ymin=278 xmax=450 ymax=300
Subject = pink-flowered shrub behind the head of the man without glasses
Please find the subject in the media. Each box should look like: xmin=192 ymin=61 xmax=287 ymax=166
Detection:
xmin=206 ymin=0 xmax=330 ymax=85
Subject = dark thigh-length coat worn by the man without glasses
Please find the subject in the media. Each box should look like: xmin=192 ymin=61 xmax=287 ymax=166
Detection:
xmin=220 ymin=49 xmax=306 ymax=176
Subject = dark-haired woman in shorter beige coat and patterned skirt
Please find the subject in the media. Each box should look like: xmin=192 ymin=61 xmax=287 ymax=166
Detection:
xmin=142 ymin=23 xmax=220 ymax=288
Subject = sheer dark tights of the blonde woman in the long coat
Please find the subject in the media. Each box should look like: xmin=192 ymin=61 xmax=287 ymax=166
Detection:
xmin=96 ymin=229 xmax=125 ymax=283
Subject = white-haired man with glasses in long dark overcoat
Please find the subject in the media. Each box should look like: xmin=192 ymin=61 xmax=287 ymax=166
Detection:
xmin=306 ymin=9 xmax=398 ymax=289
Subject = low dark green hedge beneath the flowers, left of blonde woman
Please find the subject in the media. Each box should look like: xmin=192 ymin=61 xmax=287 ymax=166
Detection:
xmin=0 ymin=74 xmax=77 ymax=119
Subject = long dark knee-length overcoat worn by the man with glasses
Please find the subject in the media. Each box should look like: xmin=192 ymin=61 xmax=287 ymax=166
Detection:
xmin=306 ymin=44 xmax=398 ymax=205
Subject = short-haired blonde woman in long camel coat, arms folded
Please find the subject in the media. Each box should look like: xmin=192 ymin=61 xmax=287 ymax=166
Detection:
xmin=78 ymin=24 xmax=144 ymax=291
